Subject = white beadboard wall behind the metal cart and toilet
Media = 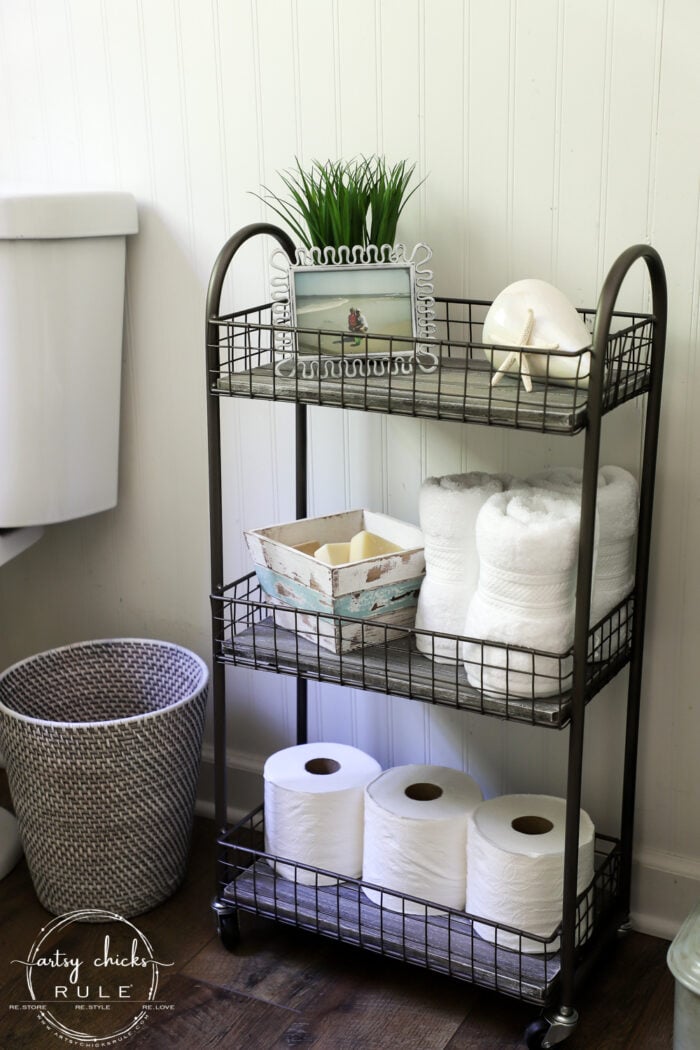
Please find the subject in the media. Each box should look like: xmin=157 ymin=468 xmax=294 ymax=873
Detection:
xmin=0 ymin=0 xmax=700 ymax=936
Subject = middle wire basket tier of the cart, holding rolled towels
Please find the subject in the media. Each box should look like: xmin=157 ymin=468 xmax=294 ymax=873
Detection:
xmin=212 ymin=572 xmax=634 ymax=729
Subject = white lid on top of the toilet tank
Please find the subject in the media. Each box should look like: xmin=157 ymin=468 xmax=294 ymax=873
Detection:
xmin=0 ymin=187 xmax=139 ymax=240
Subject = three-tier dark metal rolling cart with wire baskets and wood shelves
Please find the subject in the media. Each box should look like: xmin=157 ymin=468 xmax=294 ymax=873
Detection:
xmin=206 ymin=224 xmax=666 ymax=1050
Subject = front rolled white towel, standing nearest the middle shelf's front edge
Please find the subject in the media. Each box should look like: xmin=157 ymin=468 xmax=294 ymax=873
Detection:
xmin=463 ymin=488 xmax=580 ymax=697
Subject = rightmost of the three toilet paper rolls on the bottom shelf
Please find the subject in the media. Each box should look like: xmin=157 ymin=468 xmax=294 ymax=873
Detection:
xmin=466 ymin=795 xmax=595 ymax=953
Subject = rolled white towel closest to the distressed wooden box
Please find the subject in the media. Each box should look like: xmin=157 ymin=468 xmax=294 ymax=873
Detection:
xmin=416 ymin=470 xmax=509 ymax=663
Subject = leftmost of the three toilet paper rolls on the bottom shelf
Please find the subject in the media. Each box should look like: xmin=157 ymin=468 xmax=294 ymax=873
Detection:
xmin=263 ymin=743 xmax=382 ymax=886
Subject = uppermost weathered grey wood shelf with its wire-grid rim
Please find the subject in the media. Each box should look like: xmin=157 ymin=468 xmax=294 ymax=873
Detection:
xmin=210 ymin=299 xmax=653 ymax=434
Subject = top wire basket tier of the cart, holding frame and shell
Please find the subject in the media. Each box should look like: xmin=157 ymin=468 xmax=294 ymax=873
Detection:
xmin=209 ymin=298 xmax=654 ymax=434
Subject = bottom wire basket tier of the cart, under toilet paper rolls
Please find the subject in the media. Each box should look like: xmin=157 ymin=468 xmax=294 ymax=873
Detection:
xmin=218 ymin=806 xmax=619 ymax=1003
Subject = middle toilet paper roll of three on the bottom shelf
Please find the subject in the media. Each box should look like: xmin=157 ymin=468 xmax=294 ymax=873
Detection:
xmin=362 ymin=765 xmax=483 ymax=915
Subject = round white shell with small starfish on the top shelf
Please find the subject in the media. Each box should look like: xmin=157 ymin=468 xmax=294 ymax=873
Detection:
xmin=483 ymin=277 xmax=591 ymax=392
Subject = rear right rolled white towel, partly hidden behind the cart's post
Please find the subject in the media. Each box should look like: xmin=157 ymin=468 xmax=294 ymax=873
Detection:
xmin=528 ymin=466 xmax=639 ymax=660
